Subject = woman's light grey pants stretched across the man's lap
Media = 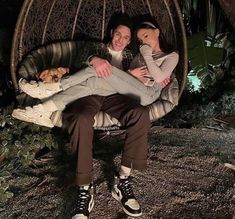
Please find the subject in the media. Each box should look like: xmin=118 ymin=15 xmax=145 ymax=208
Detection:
xmin=50 ymin=67 xmax=162 ymax=110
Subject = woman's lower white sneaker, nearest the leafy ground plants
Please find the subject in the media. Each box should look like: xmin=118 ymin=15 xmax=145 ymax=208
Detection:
xmin=12 ymin=104 xmax=54 ymax=128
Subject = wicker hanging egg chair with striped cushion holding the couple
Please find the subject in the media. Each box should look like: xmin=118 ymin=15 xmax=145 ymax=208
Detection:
xmin=11 ymin=0 xmax=188 ymax=128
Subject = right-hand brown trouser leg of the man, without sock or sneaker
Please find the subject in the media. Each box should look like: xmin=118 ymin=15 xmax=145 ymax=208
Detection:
xmin=101 ymin=94 xmax=151 ymax=170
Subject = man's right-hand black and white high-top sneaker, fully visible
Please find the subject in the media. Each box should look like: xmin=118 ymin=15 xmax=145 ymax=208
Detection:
xmin=112 ymin=177 xmax=142 ymax=217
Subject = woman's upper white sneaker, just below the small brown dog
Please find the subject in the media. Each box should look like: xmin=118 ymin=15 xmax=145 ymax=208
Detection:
xmin=19 ymin=78 xmax=62 ymax=99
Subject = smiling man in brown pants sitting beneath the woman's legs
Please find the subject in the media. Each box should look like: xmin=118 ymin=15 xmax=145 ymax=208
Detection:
xmin=12 ymin=13 xmax=150 ymax=219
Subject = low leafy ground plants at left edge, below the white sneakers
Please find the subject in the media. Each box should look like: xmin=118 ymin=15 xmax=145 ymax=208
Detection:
xmin=0 ymin=109 xmax=57 ymax=203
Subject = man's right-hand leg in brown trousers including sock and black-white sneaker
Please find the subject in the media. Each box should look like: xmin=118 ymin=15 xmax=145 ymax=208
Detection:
xmin=101 ymin=95 xmax=151 ymax=217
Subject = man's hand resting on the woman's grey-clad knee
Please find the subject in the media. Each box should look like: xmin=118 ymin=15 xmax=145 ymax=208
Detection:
xmin=90 ymin=56 xmax=112 ymax=78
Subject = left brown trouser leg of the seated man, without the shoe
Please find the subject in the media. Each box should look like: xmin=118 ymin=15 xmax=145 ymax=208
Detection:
xmin=63 ymin=96 xmax=103 ymax=185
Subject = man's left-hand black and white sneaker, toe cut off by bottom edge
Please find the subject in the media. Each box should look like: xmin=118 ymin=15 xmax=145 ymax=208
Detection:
xmin=72 ymin=186 xmax=94 ymax=219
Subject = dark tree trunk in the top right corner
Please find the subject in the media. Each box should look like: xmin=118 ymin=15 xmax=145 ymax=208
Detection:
xmin=219 ymin=0 xmax=235 ymax=29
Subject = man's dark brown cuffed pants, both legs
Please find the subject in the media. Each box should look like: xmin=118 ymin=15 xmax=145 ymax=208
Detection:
xmin=63 ymin=94 xmax=150 ymax=185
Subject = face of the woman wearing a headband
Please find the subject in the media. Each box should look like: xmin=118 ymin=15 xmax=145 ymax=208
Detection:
xmin=137 ymin=28 xmax=159 ymax=51
